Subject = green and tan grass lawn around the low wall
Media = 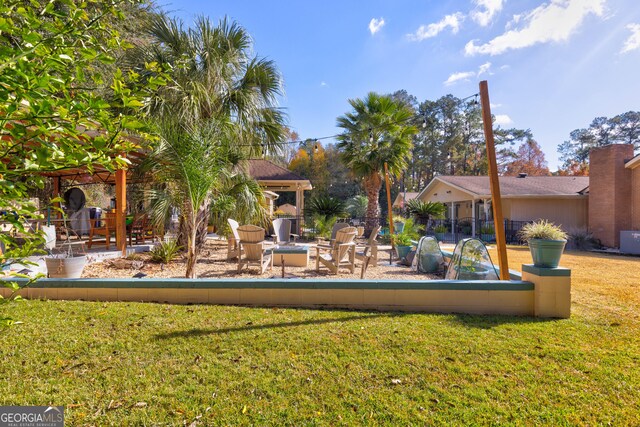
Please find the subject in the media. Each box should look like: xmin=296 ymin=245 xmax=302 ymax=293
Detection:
xmin=0 ymin=247 xmax=640 ymax=426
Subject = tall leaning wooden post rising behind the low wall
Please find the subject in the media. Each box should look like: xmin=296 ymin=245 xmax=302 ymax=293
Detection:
xmin=480 ymin=80 xmax=510 ymax=280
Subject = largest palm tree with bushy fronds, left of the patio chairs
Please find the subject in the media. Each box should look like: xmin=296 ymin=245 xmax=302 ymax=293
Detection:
xmin=126 ymin=14 xmax=284 ymax=277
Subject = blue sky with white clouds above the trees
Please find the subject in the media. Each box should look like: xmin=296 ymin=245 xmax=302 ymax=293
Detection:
xmin=164 ymin=0 xmax=640 ymax=170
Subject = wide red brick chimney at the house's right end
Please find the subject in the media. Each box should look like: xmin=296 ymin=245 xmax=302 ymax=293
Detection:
xmin=589 ymin=144 xmax=633 ymax=248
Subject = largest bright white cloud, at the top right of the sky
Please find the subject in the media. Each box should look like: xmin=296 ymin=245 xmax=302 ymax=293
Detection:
xmin=464 ymin=0 xmax=606 ymax=55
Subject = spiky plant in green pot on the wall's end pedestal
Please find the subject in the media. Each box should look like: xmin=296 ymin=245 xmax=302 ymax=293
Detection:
xmin=518 ymin=219 xmax=567 ymax=268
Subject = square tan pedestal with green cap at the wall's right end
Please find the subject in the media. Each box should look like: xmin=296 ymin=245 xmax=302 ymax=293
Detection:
xmin=522 ymin=264 xmax=571 ymax=319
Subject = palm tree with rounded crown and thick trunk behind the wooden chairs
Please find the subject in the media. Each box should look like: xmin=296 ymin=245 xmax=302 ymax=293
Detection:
xmin=338 ymin=92 xmax=417 ymax=232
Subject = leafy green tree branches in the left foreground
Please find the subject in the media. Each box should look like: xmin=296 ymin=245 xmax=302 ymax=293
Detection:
xmin=0 ymin=0 xmax=164 ymax=325
